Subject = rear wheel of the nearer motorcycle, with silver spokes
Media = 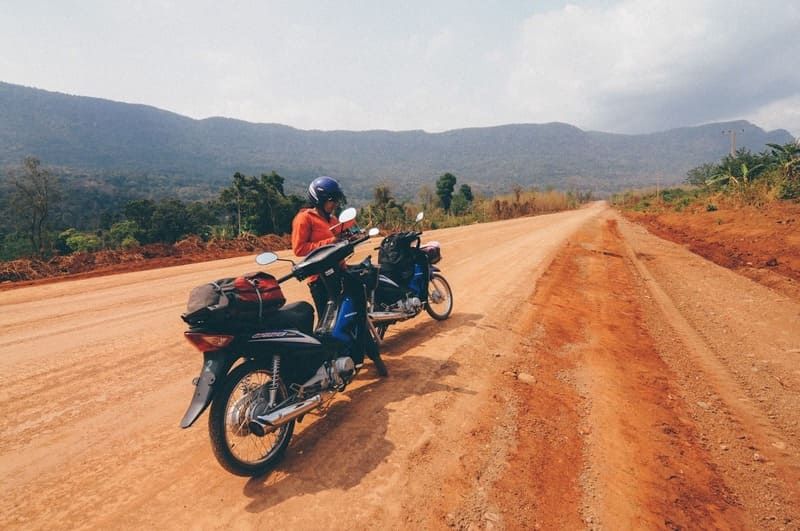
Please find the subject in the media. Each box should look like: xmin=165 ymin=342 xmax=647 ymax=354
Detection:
xmin=208 ymin=361 xmax=294 ymax=476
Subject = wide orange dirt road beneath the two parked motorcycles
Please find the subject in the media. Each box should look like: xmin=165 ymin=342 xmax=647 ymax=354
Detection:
xmin=0 ymin=203 xmax=800 ymax=529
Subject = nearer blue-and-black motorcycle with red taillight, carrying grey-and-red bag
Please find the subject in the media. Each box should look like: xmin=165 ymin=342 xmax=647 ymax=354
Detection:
xmin=180 ymin=208 xmax=386 ymax=476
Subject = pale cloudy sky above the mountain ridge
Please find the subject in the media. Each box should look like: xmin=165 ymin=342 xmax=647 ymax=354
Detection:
xmin=0 ymin=0 xmax=800 ymax=137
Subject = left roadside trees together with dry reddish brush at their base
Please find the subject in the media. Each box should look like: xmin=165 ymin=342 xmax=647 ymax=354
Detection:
xmin=0 ymin=158 xmax=591 ymax=282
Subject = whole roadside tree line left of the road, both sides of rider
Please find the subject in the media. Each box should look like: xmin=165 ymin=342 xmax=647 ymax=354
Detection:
xmin=0 ymin=157 xmax=591 ymax=260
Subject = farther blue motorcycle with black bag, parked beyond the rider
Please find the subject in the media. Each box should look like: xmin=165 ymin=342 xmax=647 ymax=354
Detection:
xmin=367 ymin=212 xmax=453 ymax=341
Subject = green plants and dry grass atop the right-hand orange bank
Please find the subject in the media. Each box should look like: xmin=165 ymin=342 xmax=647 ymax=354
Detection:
xmin=612 ymin=143 xmax=800 ymax=212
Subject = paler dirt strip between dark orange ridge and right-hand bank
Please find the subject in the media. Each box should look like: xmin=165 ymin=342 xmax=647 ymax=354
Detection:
xmin=621 ymin=214 xmax=800 ymax=529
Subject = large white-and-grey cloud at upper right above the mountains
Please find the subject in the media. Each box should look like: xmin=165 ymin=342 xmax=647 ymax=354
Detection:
xmin=508 ymin=0 xmax=800 ymax=132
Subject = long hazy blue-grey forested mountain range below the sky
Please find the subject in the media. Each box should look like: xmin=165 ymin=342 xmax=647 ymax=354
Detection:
xmin=0 ymin=82 xmax=793 ymax=201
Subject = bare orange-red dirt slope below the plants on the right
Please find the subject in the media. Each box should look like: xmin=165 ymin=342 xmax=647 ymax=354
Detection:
xmin=624 ymin=202 xmax=800 ymax=294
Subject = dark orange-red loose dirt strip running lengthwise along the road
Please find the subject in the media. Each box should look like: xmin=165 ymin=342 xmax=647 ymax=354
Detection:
xmin=495 ymin=214 xmax=747 ymax=529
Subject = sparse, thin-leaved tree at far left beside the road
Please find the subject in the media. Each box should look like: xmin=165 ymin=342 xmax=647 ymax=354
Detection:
xmin=11 ymin=157 xmax=59 ymax=256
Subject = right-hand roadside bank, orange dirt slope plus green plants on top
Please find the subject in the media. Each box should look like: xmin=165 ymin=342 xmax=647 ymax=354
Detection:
xmin=613 ymin=144 xmax=800 ymax=297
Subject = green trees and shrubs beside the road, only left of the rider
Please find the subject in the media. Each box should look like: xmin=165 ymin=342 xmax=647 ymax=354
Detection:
xmin=0 ymin=162 xmax=305 ymax=260
